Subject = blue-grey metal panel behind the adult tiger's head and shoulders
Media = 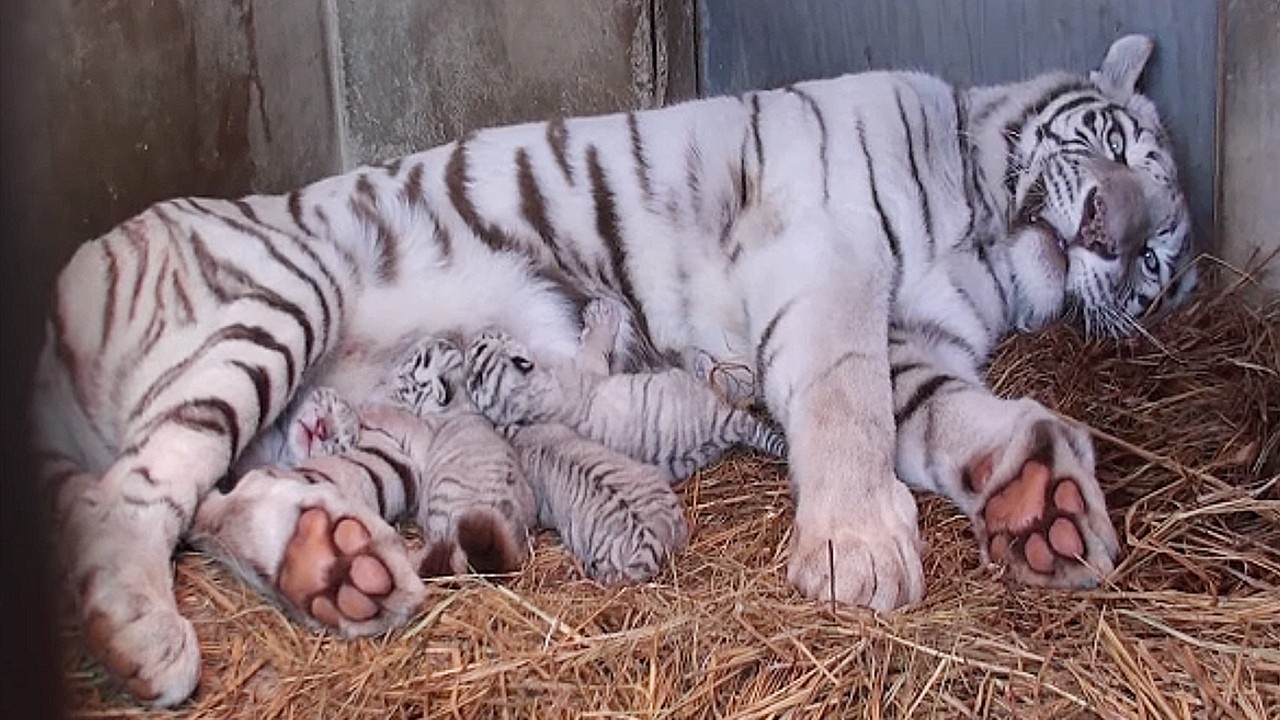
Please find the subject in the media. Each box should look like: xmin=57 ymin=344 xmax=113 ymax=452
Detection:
xmin=699 ymin=0 xmax=1219 ymax=237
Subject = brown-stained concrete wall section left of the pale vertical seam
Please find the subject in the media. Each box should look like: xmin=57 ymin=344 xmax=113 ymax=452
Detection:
xmin=5 ymin=0 xmax=339 ymax=299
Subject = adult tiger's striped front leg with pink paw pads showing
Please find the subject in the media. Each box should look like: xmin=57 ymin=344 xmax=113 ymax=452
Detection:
xmin=890 ymin=332 xmax=1119 ymax=588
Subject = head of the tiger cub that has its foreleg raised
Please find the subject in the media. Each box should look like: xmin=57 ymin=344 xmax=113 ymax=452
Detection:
xmin=465 ymin=332 xmax=561 ymax=425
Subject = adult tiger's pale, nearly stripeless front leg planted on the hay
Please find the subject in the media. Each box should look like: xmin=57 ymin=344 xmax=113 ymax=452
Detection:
xmin=740 ymin=208 xmax=924 ymax=610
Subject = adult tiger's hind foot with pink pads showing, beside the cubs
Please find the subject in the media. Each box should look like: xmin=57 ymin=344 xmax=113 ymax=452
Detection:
xmin=192 ymin=469 xmax=426 ymax=637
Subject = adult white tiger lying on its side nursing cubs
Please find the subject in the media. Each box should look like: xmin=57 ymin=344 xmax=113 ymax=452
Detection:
xmin=36 ymin=37 xmax=1194 ymax=705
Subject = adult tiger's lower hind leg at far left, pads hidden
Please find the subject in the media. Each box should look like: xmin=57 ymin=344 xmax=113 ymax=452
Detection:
xmin=59 ymin=405 xmax=248 ymax=706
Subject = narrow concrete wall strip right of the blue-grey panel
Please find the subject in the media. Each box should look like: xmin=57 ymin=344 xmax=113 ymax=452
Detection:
xmin=1220 ymin=0 xmax=1280 ymax=291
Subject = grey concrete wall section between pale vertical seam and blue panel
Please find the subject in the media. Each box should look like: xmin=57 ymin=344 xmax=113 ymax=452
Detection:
xmin=335 ymin=0 xmax=655 ymax=165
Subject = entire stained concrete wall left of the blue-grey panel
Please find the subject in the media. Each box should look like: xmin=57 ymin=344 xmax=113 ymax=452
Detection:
xmin=4 ymin=0 xmax=694 ymax=315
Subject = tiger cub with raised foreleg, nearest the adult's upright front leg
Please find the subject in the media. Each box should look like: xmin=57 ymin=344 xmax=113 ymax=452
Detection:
xmin=466 ymin=300 xmax=787 ymax=479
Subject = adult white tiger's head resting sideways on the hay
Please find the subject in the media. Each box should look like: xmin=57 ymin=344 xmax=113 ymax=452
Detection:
xmin=1004 ymin=35 xmax=1196 ymax=336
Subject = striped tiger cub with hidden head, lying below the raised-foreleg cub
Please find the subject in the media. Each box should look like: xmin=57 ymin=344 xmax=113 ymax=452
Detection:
xmin=511 ymin=424 xmax=689 ymax=583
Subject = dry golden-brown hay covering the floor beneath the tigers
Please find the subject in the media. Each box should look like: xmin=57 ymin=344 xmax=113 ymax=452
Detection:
xmin=67 ymin=278 xmax=1280 ymax=719
